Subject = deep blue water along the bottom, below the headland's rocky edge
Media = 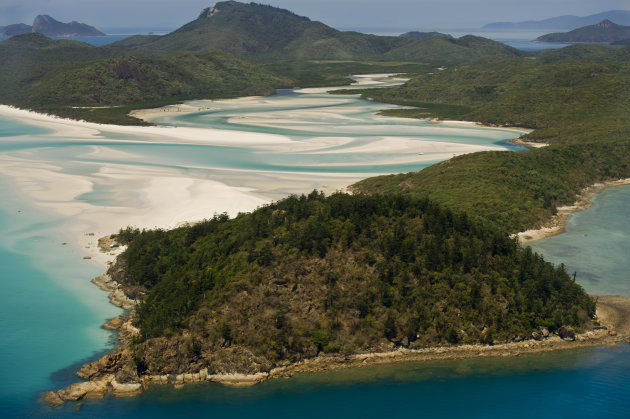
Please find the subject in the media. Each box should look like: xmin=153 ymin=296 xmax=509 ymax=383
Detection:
xmin=17 ymin=344 xmax=630 ymax=419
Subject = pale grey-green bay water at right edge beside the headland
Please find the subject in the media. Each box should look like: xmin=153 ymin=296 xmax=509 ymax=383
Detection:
xmin=531 ymin=186 xmax=630 ymax=295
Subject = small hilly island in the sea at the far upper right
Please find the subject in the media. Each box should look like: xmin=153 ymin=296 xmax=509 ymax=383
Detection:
xmin=536 ymin=19 xmax=630 ymax=44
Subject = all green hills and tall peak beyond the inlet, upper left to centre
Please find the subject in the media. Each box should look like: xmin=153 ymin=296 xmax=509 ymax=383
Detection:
xmin=0 ymin=2 xmax=532 ymax=124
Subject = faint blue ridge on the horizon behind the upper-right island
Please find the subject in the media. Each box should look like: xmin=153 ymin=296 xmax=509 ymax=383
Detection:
xmin=483 ymin=10 xmax=630 ymax=29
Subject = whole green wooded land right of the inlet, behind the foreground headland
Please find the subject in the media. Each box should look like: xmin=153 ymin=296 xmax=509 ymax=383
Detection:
xmin=348 ymin=45 xmax=630 ymax=232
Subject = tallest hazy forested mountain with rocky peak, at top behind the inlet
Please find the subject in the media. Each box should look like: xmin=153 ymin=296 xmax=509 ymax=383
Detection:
xmin=108 ymin=1 xmax=522 ymax=63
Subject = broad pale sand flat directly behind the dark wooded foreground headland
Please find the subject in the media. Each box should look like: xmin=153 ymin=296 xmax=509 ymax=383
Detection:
xmin=0 ymin=156 xmax=269 ymax=264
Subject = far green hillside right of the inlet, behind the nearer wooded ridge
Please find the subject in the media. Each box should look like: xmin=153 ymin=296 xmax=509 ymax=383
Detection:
xmin=336 ymin=46 xmax=630 ymax=143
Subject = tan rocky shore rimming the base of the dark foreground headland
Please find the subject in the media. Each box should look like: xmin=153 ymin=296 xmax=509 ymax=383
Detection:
xmin=43 ymin=231 xmax=630 ymax=406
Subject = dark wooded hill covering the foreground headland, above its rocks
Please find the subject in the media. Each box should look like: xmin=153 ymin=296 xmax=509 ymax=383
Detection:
xmin=115 ymin=191 xmax=595 ymax=374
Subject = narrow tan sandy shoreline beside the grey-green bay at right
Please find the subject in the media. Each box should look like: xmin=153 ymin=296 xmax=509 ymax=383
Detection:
xmin=515 ymin=178 xmax=630 ymax=244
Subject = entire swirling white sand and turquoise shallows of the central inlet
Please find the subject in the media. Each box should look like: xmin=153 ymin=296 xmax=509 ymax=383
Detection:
xmin=0 ymin=75 xmax=523 ymax=268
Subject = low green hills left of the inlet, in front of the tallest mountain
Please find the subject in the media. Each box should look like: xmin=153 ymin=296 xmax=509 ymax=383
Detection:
xmin=0 ymin=34 xmax=290 ymax=124
